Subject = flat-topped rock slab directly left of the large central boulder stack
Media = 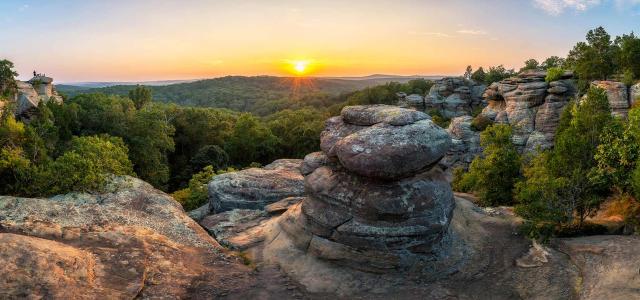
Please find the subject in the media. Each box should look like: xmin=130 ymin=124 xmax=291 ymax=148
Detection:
xmin=208 ymin=159 xmax=304 ymax=213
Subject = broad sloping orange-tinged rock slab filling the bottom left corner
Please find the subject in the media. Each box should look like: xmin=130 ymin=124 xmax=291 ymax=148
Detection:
xmin=0 ymin=177 xmax=251 ymax=299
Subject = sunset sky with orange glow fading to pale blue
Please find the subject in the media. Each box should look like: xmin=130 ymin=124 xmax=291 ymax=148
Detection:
xmin=0 ymin=0 xmax=640 ymax=83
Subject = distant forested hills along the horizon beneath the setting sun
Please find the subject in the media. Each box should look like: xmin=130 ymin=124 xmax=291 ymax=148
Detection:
xmin=57 ymin=75 xmax=441 ymax=111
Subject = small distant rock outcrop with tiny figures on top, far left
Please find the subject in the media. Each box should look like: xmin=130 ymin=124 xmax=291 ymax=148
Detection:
xmin=14 ymin=76 xmax=62 ymax=118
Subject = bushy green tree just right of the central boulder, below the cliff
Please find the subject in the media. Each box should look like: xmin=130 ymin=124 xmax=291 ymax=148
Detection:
xmin=456 ymin=124 xmax=520 ymax=206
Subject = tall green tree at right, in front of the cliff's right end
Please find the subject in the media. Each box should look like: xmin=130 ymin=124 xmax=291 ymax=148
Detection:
xmin=516 ymin=88 xmax=613 ymax=239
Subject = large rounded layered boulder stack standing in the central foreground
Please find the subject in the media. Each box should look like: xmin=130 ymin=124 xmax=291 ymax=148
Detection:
xmin=279 ymin=105 xmax=455 ymax=272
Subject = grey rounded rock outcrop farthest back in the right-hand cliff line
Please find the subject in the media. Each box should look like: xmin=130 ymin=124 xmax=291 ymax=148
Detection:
xmin=422 ymin=77 xmax=486 ymax=118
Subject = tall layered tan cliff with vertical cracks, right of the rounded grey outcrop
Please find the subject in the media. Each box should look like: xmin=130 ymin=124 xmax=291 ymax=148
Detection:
xmin=481 ymin=71 xmax=576 ymax=151
